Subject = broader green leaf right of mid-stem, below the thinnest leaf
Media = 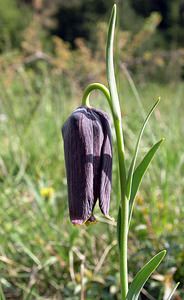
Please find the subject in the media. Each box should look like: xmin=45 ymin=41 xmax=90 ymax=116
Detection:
xmin=129 ymin=139 xmax=164 ymax=223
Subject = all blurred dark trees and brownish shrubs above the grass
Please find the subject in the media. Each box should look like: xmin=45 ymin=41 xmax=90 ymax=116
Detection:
xmin=0 ymin=0 xmax=184 ymax=82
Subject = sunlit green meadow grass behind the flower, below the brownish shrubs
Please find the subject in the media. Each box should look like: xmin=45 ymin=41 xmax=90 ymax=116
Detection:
xmin=0 ymin=68 xmax=184 ymax=300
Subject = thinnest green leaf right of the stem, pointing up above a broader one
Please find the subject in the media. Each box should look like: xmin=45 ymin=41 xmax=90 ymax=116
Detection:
xmin=126 ymin=98 xmax=160 ymax=199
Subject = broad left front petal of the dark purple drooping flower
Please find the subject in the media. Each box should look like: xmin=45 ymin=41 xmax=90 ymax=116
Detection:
xmin=62 ymin=107 xmax=103 ymax=224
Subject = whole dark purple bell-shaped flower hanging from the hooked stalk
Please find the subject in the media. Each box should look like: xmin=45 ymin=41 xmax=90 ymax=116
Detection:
xmin=62 ymin=107 xmax=112 ymax=224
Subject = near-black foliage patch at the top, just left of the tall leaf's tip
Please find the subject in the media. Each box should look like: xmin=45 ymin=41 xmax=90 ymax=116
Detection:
xmin=49 ymin=0 xmax=114 ymax=47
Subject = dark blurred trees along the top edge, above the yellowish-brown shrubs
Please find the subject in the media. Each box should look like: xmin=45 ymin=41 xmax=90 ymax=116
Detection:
xmin=0 ymin=0 xmax=184 ymax=49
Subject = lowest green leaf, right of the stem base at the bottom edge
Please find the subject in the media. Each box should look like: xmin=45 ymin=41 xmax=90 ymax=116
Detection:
xmin=126 ymin=250 xmax=166 ymax=300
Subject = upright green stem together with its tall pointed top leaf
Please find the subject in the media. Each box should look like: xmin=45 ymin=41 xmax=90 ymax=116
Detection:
xmin=106 ymin=4 xmax=129 ymax=300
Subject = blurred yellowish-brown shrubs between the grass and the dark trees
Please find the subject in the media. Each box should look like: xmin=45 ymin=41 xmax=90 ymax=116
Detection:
xmin=0 ymin=7 xmax=184 ymax=87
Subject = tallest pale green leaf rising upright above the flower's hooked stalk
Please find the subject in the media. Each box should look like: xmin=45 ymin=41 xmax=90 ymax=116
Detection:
xmin=106 ymin=4 xmax=121 ymax=119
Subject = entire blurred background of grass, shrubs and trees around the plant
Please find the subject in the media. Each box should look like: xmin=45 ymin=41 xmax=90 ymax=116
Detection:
xmin=0 ymin=0 xmax=184 ymax=300
